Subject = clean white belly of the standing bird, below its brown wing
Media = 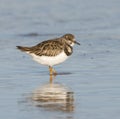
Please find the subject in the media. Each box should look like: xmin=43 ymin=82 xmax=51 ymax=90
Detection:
xmin=30 ymin=52 xmax=68 ymax=66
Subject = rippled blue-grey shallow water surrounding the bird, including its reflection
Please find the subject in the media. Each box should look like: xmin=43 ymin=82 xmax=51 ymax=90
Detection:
xmin=0 ymin=0 xmax=120 ymax=119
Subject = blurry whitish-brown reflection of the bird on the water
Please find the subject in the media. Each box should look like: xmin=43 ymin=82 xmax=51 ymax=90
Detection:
xmin=32 ymin=76 xmax=74 ymax=112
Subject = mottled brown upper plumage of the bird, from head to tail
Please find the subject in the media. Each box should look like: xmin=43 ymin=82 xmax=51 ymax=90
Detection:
xmin=17 ymin=34 xmax=79 ymax=56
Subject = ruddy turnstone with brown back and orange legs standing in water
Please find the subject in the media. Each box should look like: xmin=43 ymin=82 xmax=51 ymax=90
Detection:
xmin=16 ymin=34 xmax=80 ymax=75
